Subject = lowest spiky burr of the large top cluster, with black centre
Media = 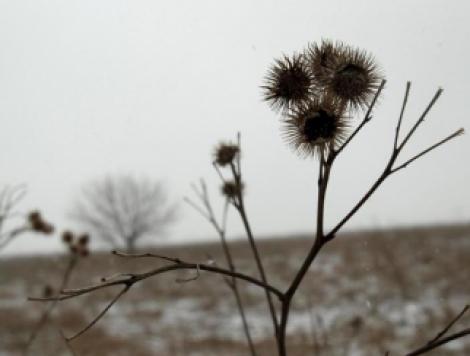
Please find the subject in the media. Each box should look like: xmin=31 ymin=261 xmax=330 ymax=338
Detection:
xmin=283 ymin=97 xmax=347 ymax=157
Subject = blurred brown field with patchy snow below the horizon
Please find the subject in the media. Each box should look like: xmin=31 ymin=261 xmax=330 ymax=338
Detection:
xmin=0 ymin=225 xmax=470 ymax=356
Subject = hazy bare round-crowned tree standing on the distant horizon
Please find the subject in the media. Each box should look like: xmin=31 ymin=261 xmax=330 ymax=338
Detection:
xmin=71 ymin=175 xmax=175 ymax=252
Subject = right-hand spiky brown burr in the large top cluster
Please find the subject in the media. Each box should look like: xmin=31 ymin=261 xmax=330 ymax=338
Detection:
xmin=325 ymin=47 xmax=382 ymax=109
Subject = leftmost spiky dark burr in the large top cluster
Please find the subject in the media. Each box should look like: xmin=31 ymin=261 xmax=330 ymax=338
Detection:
xmin=262 ymin=54 xmax=313 ymax=110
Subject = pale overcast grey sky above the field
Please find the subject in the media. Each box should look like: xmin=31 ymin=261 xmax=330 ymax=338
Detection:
xmin=0 ymin=0 xmax=470 ymax=252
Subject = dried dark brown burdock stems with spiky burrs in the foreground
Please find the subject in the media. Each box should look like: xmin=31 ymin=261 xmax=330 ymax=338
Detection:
xmin=30 ymin=41 xmax=470 ymax=356
